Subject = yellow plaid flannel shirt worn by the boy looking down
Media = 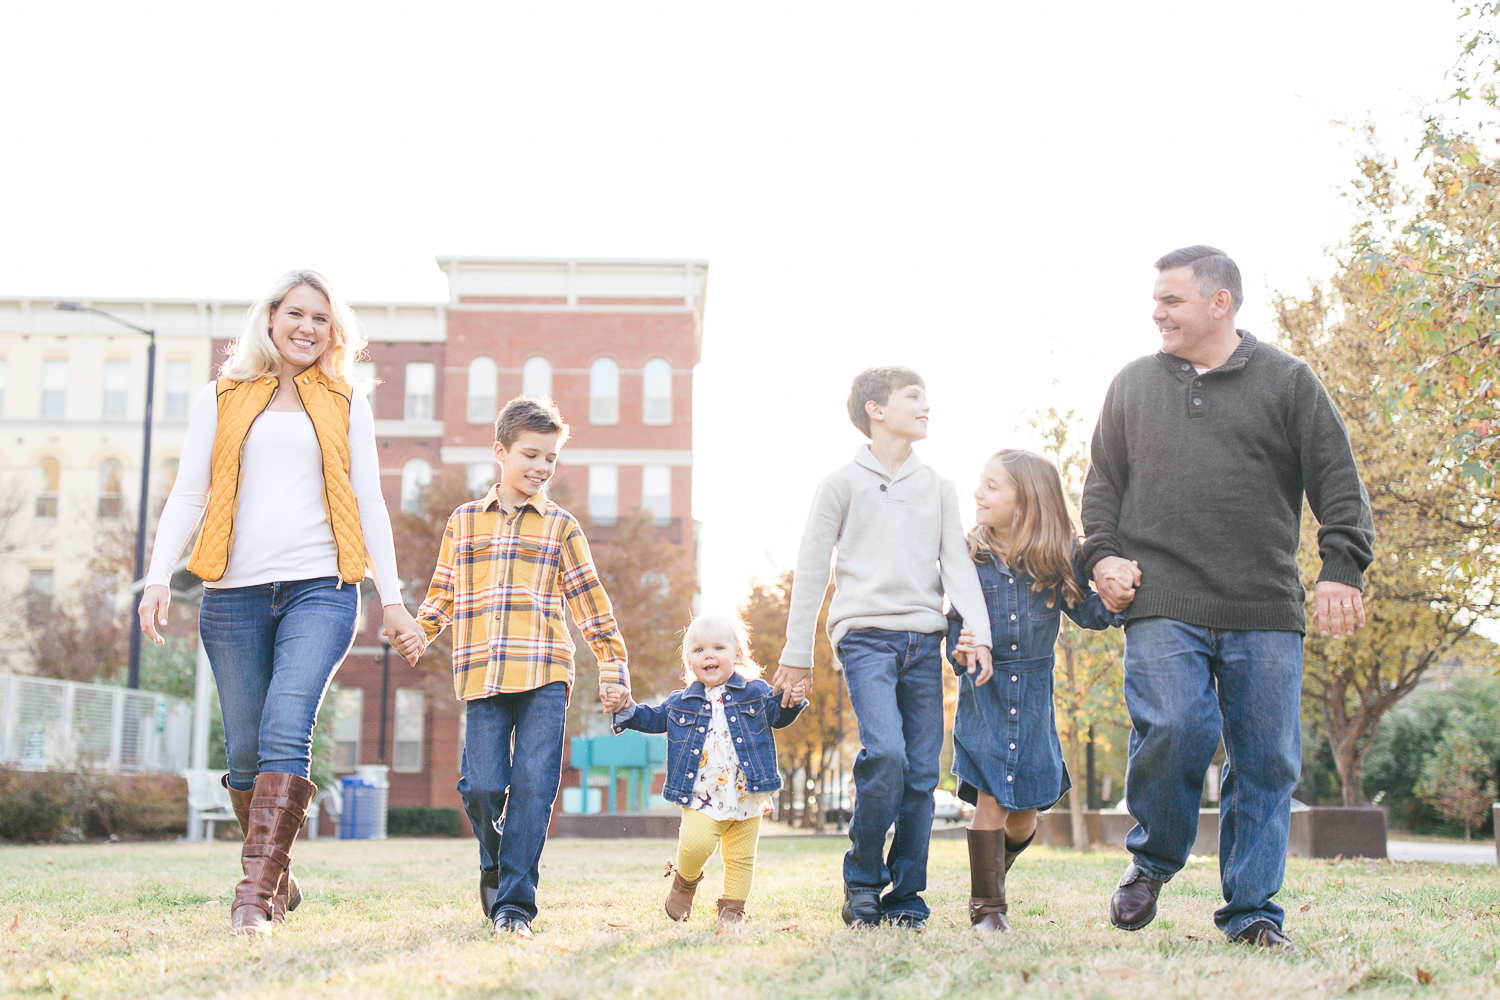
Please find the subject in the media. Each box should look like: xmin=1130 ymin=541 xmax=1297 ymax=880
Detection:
xmin=417 ymin=486 xmax=630 ymax=702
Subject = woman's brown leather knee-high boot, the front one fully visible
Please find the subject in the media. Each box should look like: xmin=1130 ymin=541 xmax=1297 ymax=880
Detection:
xmin=230 ymin=772 xmax=318 ymax=934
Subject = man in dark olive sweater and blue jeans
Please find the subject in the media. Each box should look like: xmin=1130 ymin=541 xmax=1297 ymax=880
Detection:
xmin=1080 ymin=246 xmax=1374 ymax=951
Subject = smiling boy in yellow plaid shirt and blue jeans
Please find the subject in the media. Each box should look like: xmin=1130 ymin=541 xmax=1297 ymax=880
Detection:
xmin=417 ymin=396 xmax=630 ymax=937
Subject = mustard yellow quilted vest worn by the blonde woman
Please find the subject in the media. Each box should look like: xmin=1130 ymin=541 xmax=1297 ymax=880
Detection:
xmin=188 ymin=366 xmax=365 ymax=583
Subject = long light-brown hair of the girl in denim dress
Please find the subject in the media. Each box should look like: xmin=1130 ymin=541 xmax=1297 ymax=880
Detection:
xmin=969 ymin=448 xmax=1083 ymax=607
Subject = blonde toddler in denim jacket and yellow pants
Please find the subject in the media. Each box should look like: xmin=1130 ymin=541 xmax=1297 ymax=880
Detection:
xmin=611 ymin=615 xmax=807 ymax=924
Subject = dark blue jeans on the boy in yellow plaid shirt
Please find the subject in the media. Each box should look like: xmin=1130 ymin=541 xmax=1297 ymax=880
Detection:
xmin=459 ymin=681 xmax=567 ymax=924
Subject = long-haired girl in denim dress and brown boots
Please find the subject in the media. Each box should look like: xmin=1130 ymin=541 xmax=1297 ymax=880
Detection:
xmin=948 ymin=448 xmax=1125 ymax=931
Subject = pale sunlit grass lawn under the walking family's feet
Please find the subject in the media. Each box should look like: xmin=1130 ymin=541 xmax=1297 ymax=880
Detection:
xmin=0 ymin=837 xmax=1500 ymax=1000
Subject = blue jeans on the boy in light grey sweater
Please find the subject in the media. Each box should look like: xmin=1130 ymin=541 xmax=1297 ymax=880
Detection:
xmin=839 ymin=628 xmax=942 ymax=921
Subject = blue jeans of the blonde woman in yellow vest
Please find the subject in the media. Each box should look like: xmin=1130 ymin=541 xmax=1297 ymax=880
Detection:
xmin=198 ymin=577 xmax=360 ymax=792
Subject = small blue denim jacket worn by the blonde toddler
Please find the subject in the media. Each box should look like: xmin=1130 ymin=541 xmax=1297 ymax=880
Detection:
xmin=612 ymin=673 xmax=807 ymax=805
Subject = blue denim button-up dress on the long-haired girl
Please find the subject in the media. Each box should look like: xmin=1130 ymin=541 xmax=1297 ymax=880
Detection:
xmin=948 ymin=553 xmax=1125 ymax=811
